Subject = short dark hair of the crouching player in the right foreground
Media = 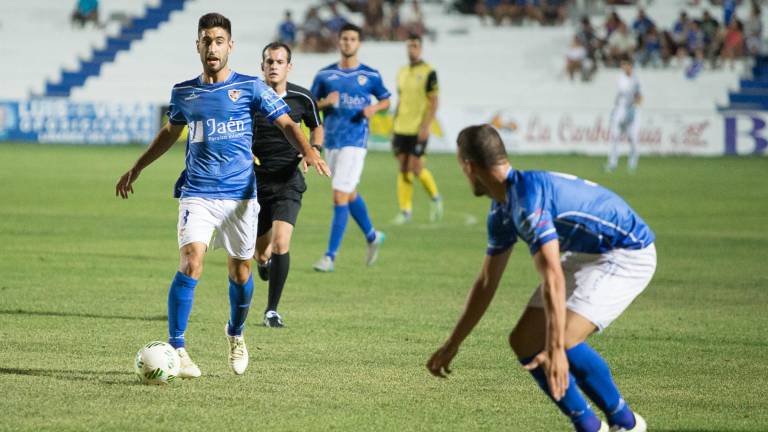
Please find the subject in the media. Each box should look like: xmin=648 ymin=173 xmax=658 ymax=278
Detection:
xmin=456 ymin=124 xmax=507 ymax=169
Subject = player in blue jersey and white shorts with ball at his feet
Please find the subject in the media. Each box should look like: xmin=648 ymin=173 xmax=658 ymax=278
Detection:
xmin=115 ymin=13 xmax=330 ymax=378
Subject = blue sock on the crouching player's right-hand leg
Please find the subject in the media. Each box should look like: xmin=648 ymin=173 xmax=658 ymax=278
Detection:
xmin=565 ymin=342 xmax=635 ymax=429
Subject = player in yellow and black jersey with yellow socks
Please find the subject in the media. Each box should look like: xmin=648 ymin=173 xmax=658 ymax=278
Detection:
xmin=392 ymin=35 xmax=443 ymax=225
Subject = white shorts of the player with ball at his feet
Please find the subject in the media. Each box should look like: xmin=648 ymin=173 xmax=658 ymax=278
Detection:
xmin=178 ymin=197 xmax=259 ymax=260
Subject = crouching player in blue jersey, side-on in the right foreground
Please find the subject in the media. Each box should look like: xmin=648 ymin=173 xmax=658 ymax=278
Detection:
xmin=427 ymin=125 xmax=656 ymax=432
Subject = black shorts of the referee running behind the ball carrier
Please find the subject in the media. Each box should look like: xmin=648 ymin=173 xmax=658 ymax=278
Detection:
xmin=256 ymin=169 xmax=307 ymax=237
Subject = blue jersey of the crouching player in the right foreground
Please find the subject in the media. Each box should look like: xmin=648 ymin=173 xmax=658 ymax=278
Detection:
xmin=487 ymin=169 xmax=655 ymax=255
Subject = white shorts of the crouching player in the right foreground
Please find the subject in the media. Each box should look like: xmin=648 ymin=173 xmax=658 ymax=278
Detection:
xmin=528 ymin=244 xmax=656 ymax=331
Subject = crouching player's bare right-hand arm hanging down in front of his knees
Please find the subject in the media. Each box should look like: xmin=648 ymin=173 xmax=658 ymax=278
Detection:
xmin=525 ymin=239 xmax=568 ymax=400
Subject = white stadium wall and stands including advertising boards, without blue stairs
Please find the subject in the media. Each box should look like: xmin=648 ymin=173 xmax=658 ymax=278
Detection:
xmin=0 ymin=0 xmax=768 ymax=156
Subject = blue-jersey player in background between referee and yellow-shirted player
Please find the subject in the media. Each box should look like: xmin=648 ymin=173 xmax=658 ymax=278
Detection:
xmin=312 ymin=24 xmax=390 ymax=272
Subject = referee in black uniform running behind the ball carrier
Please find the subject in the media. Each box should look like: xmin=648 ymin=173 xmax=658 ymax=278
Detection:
xmin=252 ymin=42 xmax=323 ymax=327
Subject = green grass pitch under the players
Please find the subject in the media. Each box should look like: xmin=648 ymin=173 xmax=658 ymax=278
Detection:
xmin=0 ymin=144 xmax=768 ymax=431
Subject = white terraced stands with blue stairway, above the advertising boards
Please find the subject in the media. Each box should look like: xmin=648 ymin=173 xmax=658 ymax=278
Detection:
xmin=0 ymin=0 xmax=768 ymax=116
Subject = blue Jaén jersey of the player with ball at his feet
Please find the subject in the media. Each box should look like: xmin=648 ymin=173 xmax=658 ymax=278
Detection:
xmin=168 ymin=71 xmax=290 ymax=199
